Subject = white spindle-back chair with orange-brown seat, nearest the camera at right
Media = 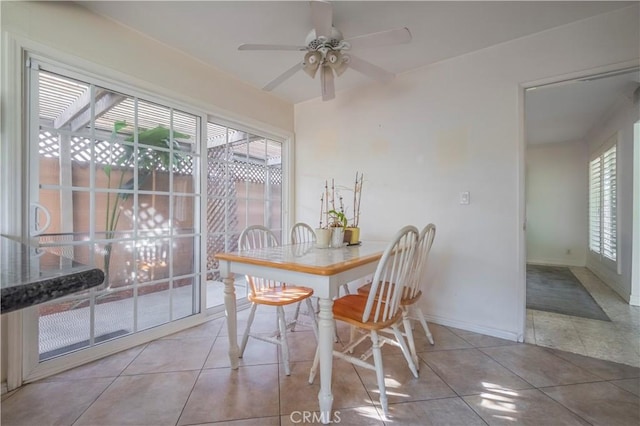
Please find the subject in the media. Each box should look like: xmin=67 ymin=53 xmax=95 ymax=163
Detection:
xmin=309 ymin=226 xmax=418 ymax=416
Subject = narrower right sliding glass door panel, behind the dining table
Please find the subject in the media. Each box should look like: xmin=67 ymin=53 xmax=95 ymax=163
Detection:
xmin=207 ymin=119 xmax=284 ymax=308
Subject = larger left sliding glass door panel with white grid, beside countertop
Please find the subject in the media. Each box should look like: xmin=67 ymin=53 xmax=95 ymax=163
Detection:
xmin=29 ymin=62 xmax=202 ymax=361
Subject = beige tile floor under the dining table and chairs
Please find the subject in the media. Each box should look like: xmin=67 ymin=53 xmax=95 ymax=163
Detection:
xmin=1 ymin=302 xmax=640 ymax=426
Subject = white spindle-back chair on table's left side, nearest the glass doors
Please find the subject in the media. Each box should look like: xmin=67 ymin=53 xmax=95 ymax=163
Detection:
xmin=238 ymin=225 xmax=318 ymax=376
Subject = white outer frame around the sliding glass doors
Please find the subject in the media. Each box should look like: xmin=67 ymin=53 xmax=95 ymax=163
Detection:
xmin=0 ymin=35 xmax=294 ymax=390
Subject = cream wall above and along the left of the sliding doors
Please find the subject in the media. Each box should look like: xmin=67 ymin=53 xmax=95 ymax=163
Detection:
xmin=0 ymin=1 xmax=293 ymax=388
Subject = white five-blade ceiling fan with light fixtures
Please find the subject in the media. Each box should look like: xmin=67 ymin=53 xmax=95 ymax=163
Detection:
xmin=238 ymin=0 xmax=411 ymax=101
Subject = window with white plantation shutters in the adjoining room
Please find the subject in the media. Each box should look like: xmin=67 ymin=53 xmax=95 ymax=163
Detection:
xmin=589 ymin=136 xmax=618 ymax=262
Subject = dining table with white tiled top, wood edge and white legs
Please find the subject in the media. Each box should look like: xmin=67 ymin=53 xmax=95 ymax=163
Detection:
xmin=215 ymin=241 xmax=387 ymax=424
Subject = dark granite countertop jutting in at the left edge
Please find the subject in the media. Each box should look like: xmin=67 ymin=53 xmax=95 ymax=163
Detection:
xmin=0 ymin=236 xmax=104 ymax=314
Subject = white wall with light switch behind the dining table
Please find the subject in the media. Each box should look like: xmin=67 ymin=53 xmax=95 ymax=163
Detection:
xmin=295 ymin=5 xmax=640 ymax=339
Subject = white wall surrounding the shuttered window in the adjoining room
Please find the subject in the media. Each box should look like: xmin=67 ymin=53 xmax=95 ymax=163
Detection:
xmin=587 ymin=92 xmax=640 ymax=305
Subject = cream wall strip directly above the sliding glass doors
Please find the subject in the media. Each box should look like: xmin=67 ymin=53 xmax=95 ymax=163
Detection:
xmin=1 ymin=2 xmax=293 ymax=131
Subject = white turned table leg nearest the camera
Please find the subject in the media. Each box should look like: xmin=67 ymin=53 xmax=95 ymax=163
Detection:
xmin=318 ymin=298 xmax=334 ymax=424
